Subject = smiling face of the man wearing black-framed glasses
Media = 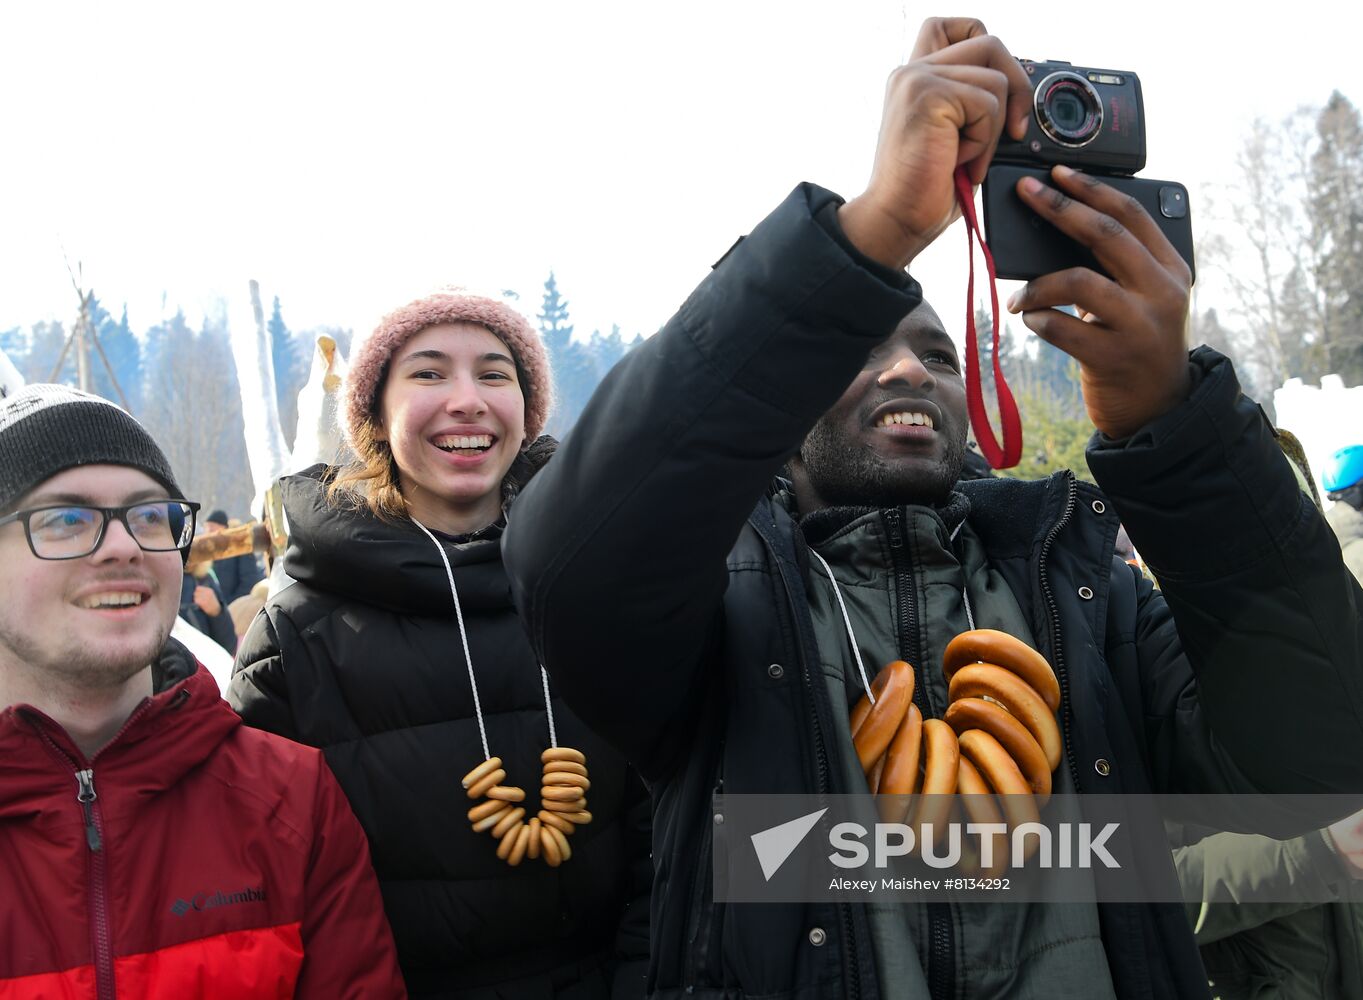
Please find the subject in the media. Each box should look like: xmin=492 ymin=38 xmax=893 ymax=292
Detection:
xmin=0 ymin=465 xmax=183 ymax=691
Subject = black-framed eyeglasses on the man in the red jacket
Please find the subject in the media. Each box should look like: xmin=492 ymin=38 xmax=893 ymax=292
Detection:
xmin=0 ymin=500 xmax=199 ymax=559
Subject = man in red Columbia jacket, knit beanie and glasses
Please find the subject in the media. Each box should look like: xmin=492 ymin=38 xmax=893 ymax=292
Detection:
xmin=0 ymin=386 xmax=406 ymax=1000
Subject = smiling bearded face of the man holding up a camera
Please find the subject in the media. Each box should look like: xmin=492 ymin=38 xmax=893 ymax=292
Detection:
xmin=791 ymin=302 xmax=968 ymax=514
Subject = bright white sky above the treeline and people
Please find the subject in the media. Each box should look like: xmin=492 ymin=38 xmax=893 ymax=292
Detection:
xmin=0 ymin=0 xmax=1363 ymax=344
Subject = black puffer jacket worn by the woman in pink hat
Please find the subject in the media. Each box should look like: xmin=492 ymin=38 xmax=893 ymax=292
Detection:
xmin=228 ymin=466 xmax=649 ymax=1000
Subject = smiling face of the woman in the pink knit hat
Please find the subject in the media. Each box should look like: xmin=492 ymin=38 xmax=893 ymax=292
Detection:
xmin=379 ymin=323 xmax=525 ymax=534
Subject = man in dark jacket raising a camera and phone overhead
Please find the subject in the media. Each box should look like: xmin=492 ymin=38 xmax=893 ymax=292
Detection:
xmin=506 ymin=19 xmax=1363 ymax=1000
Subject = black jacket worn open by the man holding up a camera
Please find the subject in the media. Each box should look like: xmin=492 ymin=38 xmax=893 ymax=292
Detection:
xmin=506 ymin=185 xmax=1363 ymax=1000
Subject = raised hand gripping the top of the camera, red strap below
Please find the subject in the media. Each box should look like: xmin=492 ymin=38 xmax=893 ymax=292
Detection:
xmin=838 ymin=18 xmax=1032 ymax=267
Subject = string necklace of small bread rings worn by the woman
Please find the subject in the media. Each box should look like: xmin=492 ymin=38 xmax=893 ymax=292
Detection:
xmin=412 ymin=518 xmax=592 ymax=868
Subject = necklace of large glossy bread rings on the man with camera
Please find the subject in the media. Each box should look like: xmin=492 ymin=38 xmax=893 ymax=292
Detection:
xmin=810 ymin=526 xmax=1063 ymax=875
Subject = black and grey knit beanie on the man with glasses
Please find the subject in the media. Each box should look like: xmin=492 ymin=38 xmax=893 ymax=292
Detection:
xmin=0 ymin=384 xmax=181 ymax=511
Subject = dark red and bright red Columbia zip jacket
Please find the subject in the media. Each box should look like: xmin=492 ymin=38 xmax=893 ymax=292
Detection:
xmin=0 ymin=642 xmax=406 ymax=1000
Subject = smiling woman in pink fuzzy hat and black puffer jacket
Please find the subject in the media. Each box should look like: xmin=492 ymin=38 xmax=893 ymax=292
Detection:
xmin=228 ymin=292 xmax=652 ymax=1000
